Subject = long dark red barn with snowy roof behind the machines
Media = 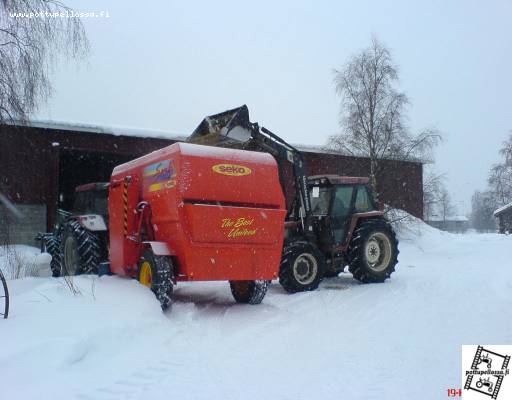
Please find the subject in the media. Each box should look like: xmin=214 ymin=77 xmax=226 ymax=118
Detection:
xmin=0 ymin=121 xmax=423 ymax=244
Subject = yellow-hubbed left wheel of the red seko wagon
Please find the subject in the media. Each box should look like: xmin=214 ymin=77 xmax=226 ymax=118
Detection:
xmin=137 ymin=250 xmax=174 ymax=311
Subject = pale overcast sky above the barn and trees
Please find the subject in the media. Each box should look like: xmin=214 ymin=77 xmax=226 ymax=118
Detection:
xmin=38 ymin=0 xmax=512 ymax=213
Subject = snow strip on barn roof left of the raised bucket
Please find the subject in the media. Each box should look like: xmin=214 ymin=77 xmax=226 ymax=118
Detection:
xmin=11 ymin=120 xmax=186 ymax=140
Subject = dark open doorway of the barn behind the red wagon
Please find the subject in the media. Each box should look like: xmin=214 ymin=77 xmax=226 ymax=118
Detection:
xmin=58 ymin=150 xmax=136 ymax=210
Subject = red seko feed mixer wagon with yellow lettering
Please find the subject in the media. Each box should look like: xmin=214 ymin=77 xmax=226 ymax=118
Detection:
xmin=109 ymin=143 xmax=286 ymax=309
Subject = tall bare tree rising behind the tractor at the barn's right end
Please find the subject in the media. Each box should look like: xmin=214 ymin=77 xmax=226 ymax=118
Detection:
xmin=328 ymin=37 xmax=441 ymax=195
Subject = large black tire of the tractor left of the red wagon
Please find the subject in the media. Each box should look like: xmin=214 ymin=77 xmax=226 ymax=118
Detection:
xmin=60 ymin=219 xmax=101 ymax=276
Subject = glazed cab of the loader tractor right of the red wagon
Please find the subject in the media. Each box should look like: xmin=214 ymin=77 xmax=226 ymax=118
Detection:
xmin=308 ymin=175 xmax=379 ymax=253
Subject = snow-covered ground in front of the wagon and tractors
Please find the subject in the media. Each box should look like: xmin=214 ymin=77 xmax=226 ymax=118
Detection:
xmin=0 ymin=221 xmax=512 ymax=400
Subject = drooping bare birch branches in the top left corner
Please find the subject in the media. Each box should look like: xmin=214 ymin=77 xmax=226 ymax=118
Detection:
xmin=0 ymin=0 xmax=89 ymax=124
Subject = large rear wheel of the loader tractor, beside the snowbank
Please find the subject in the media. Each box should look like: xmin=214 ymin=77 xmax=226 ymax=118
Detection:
xmin=348 ymin=219 xmax=399 ymax=283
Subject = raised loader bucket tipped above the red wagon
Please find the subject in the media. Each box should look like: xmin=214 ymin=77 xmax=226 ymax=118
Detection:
xmin=187 ymin=104 xmax=254 ymax=146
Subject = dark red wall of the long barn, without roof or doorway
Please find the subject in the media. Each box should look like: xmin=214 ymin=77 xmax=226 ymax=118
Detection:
xmin=0 ymin=125 xmax=423 ymax=244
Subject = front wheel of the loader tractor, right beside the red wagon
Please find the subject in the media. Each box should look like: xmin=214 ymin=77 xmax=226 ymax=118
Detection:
xmin=279 ymin=240 xmax=326 ymax=293
